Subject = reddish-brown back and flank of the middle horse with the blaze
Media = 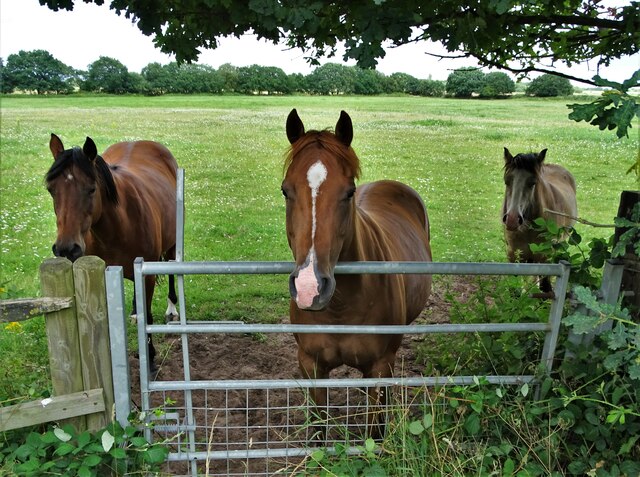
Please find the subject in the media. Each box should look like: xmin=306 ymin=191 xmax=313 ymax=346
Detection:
xmin=357 ymin=180 xmax=432 ymax=323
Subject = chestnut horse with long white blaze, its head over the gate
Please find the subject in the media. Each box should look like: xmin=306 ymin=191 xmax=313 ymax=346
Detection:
xmin=282 ymin=109 xmax=431 ymax=436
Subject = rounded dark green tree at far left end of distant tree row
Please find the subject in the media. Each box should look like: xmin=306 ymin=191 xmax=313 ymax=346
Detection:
xmin=2 ymin=50 xmax=74 ymax=94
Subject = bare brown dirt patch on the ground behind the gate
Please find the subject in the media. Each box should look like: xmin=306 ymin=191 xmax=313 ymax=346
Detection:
xmin=130 ymin=277 xmax=475 ymax=475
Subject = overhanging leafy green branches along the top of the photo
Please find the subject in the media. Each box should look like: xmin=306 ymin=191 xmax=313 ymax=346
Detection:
xmin=40 ymin=0 xmax=640 ymax=143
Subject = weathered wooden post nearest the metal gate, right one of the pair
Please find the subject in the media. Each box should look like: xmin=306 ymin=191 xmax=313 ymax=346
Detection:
xmin=73 ymin=256 xmax=114 ymax=431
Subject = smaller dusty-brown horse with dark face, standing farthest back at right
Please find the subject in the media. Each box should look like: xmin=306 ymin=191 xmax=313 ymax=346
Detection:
xmin=502 ymin=147 xmax=578 ymax=292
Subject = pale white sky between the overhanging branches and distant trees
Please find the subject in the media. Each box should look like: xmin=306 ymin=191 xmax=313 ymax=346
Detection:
xmin=0 ymin=0 xmax=640 ymax=82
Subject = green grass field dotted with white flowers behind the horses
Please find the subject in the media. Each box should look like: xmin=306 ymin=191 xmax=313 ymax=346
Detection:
xmin=0 ymin=96 xmax=639 ymax=400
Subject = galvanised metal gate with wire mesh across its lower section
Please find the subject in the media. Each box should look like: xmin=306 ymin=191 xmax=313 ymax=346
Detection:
xmin=107 ymin=256 xmax=570 ymax=475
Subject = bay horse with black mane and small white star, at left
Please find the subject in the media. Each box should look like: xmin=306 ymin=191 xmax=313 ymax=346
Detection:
xmin=45 ymin=134 xmax=178 ymax=367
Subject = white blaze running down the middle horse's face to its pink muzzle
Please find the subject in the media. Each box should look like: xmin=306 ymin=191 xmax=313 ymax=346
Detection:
xmin=295 ymin=161 xmax=327 ymax=308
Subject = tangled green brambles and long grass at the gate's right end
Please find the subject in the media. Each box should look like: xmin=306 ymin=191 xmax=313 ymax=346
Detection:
xmin=296 ymin=206 xmax=640 ymax=477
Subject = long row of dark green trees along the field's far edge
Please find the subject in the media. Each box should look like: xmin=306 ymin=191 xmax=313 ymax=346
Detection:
xmin=0 ymin=50 xmax=573 ymax=98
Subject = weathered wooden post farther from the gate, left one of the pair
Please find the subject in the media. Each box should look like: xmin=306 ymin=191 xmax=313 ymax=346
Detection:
xmin=40 ymin=258 xmax=86 ymax=430
